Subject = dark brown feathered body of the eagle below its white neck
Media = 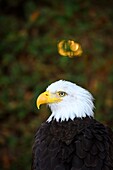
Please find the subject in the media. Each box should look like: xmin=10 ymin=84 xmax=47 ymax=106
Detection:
xmin=32 ymin=117 xmax=113 ymax=170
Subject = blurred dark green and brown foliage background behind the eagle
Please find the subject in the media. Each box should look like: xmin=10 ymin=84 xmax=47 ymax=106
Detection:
xmin=0 ymin=0 xmax=113 ymax=170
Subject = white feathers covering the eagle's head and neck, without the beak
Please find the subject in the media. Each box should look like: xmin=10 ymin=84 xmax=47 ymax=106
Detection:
xmin=46 ymin=80 xmax=94 ymax=122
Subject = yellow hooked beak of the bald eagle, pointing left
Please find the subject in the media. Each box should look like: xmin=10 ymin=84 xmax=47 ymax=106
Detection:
xmin=36 ymin=91 xmax=62 ymax=109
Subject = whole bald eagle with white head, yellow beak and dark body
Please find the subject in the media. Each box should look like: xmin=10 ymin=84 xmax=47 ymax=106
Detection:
xmin=32 ymin=80 xmax=113 ymax=170
